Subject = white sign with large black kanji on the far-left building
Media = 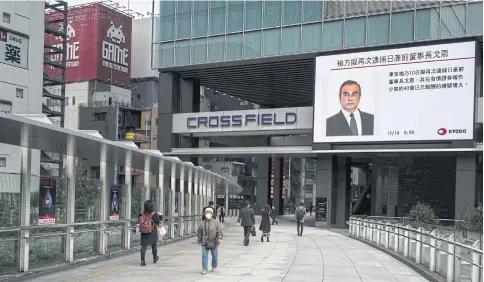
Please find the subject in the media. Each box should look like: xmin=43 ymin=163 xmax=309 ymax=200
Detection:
xmin=0 ymin=29 xmax=29 ymax=69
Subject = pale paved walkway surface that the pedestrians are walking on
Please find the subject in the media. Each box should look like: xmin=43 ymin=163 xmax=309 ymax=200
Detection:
xmin=32 ymin=219 xmax=427 ymax=282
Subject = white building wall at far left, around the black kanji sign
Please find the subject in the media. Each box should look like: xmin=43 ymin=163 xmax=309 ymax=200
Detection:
xmin=0 ymin=1 xmax=44 ymax=193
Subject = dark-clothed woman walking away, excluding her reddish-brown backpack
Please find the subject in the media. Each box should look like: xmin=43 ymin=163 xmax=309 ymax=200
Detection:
xmin=138 ymin=200 xmax=163 ymax=266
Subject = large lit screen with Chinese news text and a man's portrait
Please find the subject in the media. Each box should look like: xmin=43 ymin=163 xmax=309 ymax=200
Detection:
xmin=313 ymin=42 xmax=475 ymax=143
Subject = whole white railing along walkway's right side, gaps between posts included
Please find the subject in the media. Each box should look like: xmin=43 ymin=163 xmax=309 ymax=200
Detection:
xmin=349 ymin=217 xmax=483 ymax=282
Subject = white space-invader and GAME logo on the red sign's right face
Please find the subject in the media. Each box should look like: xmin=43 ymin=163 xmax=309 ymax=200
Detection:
xmin=102 ymin=22 xmax=129 ymax=67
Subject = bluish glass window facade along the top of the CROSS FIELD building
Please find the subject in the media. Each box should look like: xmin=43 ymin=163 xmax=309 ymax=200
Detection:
xmin=153 ymin=0 xmax=483 ymax=68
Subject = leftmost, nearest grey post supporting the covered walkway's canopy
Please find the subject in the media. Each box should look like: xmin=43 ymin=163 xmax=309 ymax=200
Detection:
xmin=18 ymin=125 xmax=32 ymax=272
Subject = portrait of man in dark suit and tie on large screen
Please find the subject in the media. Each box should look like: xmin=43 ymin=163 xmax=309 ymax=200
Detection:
xmin=326 ymin=80 xmax=375 ymax=136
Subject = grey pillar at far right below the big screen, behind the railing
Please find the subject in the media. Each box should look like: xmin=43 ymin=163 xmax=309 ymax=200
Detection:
xmin=455 ymin=155 xmax=482 ymax=219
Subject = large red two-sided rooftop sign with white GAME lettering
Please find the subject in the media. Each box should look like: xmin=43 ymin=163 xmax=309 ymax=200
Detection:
xmin=44 ymin=3 xmax=132 ymax=87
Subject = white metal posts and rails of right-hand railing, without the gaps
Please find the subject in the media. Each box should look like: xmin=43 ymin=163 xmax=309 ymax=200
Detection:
xmin=349 ymin=216 xmax=483 ymax=282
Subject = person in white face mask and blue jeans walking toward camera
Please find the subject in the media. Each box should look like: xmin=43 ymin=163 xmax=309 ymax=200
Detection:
xmin=197 ymin=208 xmax=223 ymax=274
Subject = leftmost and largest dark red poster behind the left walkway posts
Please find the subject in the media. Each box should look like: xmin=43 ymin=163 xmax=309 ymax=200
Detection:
xmin=38 ymin=178 xmax=57 ymax=225
